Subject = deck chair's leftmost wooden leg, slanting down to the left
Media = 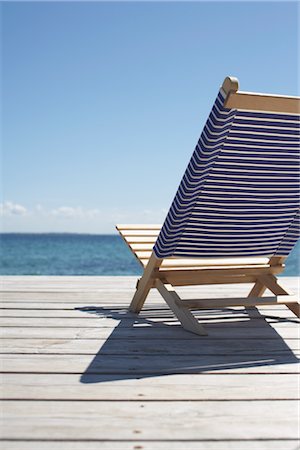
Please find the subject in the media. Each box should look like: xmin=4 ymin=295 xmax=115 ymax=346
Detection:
xmin=129 ymin=253 xmax=162 ymax=313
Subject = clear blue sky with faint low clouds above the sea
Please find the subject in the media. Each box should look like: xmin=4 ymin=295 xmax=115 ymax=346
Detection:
xmin=0 ymin=1 xmax=299 ymax=234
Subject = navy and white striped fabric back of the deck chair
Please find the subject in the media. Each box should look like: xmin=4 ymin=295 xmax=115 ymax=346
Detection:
xmin=154 ymin=89 xmax=300 ymax=258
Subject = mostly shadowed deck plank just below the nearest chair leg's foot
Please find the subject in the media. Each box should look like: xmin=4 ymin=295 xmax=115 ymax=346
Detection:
xmin=0 ymin=337 xmax=299 ymax=356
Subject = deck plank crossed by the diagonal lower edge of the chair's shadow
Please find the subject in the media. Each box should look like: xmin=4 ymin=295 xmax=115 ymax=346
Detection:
xmin=1 ymin=353 xmax=299 ymax=374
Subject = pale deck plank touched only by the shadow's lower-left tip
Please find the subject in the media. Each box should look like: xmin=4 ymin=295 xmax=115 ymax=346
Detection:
xmin=1 ymin=373 xmax=300 ymax=401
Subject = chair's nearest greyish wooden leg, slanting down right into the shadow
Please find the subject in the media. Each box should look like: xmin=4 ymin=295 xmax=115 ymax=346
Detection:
xmin=155 ymin=280 xmax=207 ymax=336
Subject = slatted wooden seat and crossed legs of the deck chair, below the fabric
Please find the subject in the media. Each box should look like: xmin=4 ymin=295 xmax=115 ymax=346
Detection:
xmin=117 ymin=225 xmax=300 ymax=336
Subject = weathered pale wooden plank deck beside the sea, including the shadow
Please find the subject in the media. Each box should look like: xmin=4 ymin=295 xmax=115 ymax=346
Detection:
xmin=0 ymin=277 xmax=299 ymax=450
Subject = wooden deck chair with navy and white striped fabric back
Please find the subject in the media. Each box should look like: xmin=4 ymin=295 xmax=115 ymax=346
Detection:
xmin=117 ymin=77 xmax=300 ymax=335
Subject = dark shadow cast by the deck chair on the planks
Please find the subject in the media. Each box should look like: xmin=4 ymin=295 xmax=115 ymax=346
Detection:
xmin=76 ymin=306 xmax=299 ymax=383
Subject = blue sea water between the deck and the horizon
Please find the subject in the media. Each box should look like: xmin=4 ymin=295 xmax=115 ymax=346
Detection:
xmin=0 ymin=233 xmax=300 ymax=276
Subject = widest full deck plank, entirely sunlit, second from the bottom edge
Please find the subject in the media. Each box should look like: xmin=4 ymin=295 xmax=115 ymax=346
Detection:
xmin=0 ymin=400 xmax=298 ymax=440
